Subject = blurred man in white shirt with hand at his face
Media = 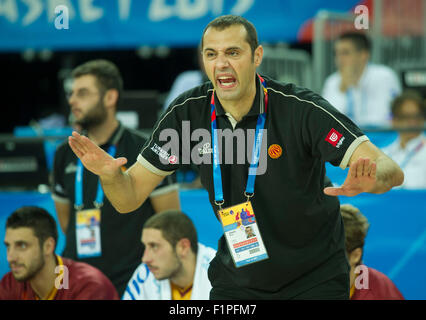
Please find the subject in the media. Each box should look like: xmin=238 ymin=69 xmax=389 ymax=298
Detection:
xmin=322 ymin=32 xmax=401 ymax=126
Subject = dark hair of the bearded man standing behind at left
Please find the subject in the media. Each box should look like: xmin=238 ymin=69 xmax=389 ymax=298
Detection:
xmin=71 ymin=59 xmax=123 ymax=101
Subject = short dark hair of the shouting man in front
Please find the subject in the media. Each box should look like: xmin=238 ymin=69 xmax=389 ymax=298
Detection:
xmin=201 ymin=14 xmax=259 ymax=54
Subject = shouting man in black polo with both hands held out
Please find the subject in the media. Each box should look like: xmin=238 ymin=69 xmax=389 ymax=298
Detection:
xmin=69 ymin=16 xmax=404 ymax=299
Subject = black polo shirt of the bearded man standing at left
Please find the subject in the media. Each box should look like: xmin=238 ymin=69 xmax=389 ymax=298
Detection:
xmin=52 ymin=124 xmax=177 ymax=296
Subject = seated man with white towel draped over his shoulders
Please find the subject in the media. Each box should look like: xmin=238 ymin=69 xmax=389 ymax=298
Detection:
xmin=123 ymin=211 xmax=216 ymax=300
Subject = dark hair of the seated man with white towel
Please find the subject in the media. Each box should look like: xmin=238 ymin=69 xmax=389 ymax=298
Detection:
xmin=143 ymin=210 xmax=198 ymax=254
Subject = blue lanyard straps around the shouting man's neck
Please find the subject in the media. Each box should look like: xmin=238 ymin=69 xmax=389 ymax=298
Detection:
xmin=210 ymin=75 xmax=268 ymax=208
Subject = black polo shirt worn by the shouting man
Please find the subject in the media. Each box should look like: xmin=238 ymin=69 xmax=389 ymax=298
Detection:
xmin=138 ymin=78 xmax=368 ymax=298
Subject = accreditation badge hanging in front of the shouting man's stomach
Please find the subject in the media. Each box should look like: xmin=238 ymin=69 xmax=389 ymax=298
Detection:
xmin=218 ymin=201 xmax=268 ymax=268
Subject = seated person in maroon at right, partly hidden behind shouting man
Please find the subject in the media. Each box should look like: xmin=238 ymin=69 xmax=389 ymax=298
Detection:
xmin=340 ymin=204 xmax=404 ymax=300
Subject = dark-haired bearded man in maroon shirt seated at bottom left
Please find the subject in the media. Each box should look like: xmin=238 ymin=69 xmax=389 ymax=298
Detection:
xmin=0 ymin=207 xmax=119 ymax=300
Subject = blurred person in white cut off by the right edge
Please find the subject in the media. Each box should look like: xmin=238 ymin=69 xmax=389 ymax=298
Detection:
xmin=383 ymin=91 xmax=426 ymax=189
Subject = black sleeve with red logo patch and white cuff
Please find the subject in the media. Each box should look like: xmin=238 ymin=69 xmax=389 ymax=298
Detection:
xmin=302 ymin=96 xmax=369 ymax=169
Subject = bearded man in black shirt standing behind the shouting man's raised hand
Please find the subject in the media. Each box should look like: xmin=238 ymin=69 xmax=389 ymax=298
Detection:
xmin=52 ymin=60 xmax=180 ymax=296
